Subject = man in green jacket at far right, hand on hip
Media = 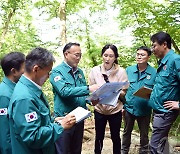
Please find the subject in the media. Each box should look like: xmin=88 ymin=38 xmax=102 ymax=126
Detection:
xmin=150 ymin=32 xmax=180 ymax=154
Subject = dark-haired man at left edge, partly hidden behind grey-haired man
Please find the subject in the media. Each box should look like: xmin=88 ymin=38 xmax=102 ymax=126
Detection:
xmin=0 ymin=52 xmax=25 ymax=154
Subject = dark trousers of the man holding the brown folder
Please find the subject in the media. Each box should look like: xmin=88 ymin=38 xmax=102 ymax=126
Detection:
xmin=122 ymin=111 xmax=151 ymax=154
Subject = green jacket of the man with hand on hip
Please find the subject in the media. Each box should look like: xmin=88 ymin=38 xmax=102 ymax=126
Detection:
xmin=150 ymin=50 xmax=180 ymax=113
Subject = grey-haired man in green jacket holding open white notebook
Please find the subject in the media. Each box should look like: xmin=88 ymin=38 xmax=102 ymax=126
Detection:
xmin=9 ymin=47 xmax=75 ymax=154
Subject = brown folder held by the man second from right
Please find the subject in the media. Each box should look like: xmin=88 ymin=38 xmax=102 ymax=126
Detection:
xmin=133 ymin=86 xmax=152 ymax=99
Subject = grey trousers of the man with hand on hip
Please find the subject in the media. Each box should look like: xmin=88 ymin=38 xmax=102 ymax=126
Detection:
xmin=150 ymin=110 xmax=179 ymax=154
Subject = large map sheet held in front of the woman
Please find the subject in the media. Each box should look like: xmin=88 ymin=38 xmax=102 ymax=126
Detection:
xmin=87 ymin=82 xmax=129 ymax=106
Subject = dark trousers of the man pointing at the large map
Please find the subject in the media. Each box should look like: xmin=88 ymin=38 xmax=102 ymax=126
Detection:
xmin=56 ymin=122 xmax=84 ymax=154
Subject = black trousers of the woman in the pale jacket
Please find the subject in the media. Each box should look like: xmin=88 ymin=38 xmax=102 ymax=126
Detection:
xmin=94 ymin=111 xmax=122 ymax=154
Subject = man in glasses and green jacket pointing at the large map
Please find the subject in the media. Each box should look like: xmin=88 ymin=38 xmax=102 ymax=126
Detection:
xmin=50 ymin=43 xmax=98 ymax=154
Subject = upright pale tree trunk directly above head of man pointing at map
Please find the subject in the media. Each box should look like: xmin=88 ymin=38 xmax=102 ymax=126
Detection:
xmin=59 ymin=0 xmax=67 ymax=46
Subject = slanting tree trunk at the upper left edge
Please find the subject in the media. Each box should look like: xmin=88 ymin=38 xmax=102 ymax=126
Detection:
xmin=0 ymin=8 xmax=16 ymax=49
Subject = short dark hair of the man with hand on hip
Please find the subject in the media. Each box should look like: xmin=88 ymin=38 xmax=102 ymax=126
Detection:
xmin=151 ymin=31 xmax=172 ymax=49
